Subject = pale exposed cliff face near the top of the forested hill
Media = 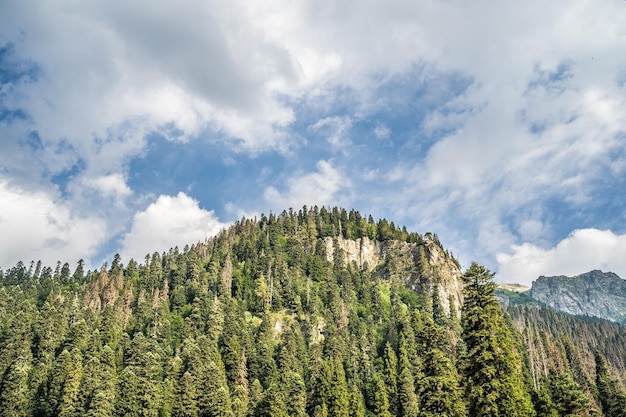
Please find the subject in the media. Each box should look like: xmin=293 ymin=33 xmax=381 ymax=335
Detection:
xmin=324 ymin=237 xmax=463 ymax=313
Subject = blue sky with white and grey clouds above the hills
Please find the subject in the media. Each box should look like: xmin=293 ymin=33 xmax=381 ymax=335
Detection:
xmin=0 ymin=0 xmax=626 ymax=284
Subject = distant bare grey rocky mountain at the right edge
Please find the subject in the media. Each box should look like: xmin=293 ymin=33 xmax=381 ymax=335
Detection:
xmin=528 ymin=270 xmax=626 ymax=323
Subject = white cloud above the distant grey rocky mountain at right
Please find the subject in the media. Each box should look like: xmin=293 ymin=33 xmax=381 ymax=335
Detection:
xmin=497 ymin=229 xmax=626 ymax=285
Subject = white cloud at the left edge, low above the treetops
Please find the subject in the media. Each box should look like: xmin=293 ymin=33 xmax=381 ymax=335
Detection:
xmin=0 ymin=179 xmax=108 ymax=269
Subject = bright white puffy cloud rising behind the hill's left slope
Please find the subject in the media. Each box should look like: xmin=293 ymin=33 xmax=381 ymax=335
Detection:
xmin=121 ymin=192 xmax=228 ymax=261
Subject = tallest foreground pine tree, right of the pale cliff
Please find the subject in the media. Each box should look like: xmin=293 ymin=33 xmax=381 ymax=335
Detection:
xmin=462 ymin=262 xmax=534 ymax=417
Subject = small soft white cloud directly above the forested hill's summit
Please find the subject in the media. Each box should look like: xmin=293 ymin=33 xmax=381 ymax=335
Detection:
xmin=263 ymin=161 xmax=351 ymax=211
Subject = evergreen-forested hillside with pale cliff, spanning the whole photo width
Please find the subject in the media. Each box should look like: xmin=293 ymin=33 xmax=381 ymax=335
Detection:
xmin=0 ymin=207 xmax=626 ymax=417
